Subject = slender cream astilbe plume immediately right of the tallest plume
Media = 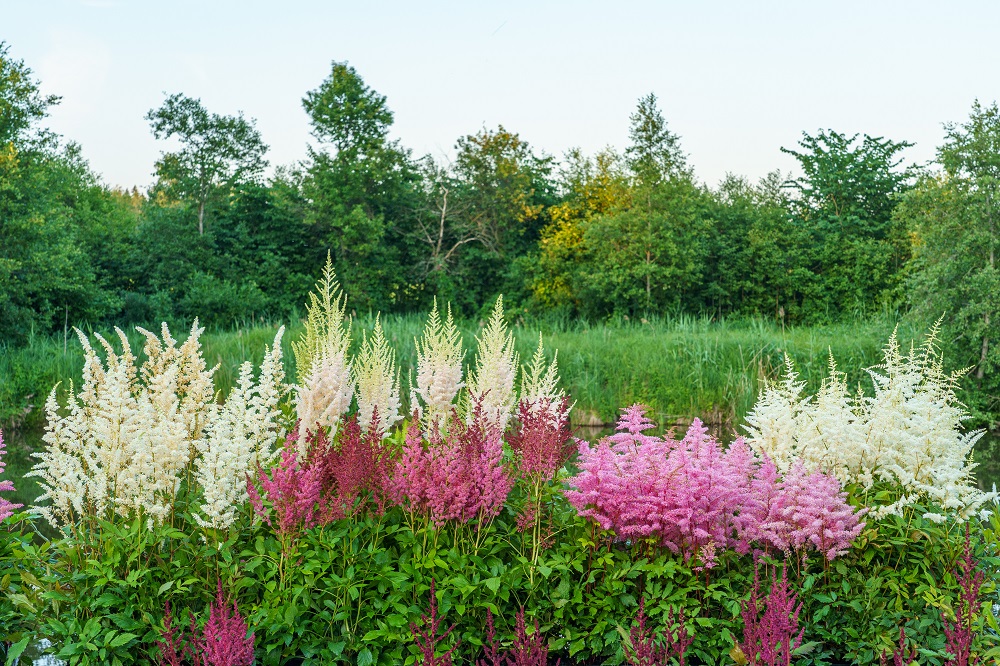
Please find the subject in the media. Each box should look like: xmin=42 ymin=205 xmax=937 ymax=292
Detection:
xmin=354 ymin=317 xmax=401 ymax=436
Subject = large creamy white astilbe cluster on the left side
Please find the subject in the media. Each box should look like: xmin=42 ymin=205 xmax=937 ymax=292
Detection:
xmin=29 ymin=321 xmax=284 ymax=527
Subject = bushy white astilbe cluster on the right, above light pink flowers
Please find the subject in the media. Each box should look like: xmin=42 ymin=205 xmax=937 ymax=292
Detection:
xmin=745 ymin=322 xmax=994 ymax=520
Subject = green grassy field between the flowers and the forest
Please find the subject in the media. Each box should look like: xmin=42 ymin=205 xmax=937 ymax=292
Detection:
xmin=0 ymin=316 xmax=956 ymax=502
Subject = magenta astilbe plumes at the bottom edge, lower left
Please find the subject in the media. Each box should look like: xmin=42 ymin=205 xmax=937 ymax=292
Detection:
xmin=157 ymin=581 xmax=254 ymax=666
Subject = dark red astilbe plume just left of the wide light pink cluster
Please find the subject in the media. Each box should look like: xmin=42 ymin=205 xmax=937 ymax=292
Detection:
xmin=507 ymin=398 xmax=576 ymax=480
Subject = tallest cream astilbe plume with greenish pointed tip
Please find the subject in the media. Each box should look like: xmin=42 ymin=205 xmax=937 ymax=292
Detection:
xmin=292 ymin=255 xmax=354 ymax=446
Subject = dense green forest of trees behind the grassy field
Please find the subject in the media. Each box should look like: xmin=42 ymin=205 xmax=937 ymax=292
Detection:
xmin=0 ymin=42 xmax=1000 ymax=440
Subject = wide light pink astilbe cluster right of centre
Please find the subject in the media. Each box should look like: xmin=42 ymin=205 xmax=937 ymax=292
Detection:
xmin=566 ymin=405 xmax=863 ymax=567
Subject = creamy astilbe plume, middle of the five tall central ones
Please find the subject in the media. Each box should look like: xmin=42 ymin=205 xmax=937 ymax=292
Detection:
xmin=410 ymin=299 xmax=465 ymax=426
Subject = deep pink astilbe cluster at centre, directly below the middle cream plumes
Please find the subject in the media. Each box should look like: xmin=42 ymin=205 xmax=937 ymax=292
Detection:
xmin=390 ymin=408 xmax=514 ymax=526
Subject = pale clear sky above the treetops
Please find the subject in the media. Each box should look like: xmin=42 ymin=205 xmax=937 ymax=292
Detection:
xmin=0 ymin=0 xmax=1000 ymax=187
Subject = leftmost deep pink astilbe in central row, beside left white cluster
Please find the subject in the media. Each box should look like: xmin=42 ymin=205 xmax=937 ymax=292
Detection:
xmin=247 ymin=429 xmax=323 ymax=535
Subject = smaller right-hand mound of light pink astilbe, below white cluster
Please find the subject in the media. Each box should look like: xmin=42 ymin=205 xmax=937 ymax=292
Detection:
xmin=745 ymin=457 xmax=865 ymax=560
